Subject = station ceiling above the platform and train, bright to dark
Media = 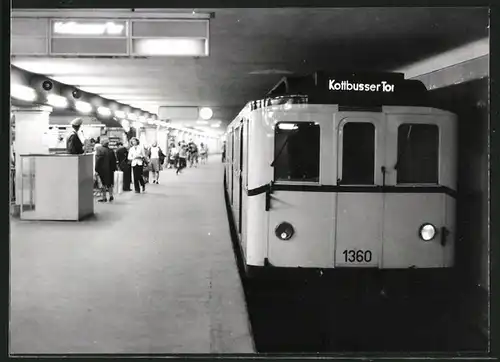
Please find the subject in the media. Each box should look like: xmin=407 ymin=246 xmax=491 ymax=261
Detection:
xmin=12 ymin=8 xmax=489 ymax=129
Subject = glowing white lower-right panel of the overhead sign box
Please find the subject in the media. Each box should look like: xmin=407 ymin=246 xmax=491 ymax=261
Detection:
xmin=133 ymin=38 xmax=207 ymax=56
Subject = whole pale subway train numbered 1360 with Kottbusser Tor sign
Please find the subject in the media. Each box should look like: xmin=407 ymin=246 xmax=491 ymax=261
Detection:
xmin=224 ymin=72 xmax=457 ymax=276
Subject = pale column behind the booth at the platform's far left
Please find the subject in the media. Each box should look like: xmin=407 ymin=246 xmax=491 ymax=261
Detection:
xmin=12 ymin=106 xmax=52 ymax=205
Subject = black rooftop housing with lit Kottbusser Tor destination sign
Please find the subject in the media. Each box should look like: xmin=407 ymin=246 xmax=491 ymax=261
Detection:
xmin=258 ymin=71 xmax=429 ymax=108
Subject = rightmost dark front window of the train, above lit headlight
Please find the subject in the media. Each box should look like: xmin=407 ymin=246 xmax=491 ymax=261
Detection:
xmin=395 ymin=124 xmax=439 ymax=184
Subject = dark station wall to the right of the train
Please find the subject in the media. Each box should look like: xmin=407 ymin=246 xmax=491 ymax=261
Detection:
xmin=431 ymin=78 xmax=489 ymax=290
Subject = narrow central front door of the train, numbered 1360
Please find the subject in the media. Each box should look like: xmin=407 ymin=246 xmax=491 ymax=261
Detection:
xmin=334 ymin=113 xmax=385 ymax=267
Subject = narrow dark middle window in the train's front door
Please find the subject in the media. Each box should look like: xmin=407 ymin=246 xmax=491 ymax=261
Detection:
xmin=339 ymin=122 xmax=375 ymax=185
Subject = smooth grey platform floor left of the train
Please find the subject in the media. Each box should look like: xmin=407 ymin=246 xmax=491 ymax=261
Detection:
xmin=9 ymin=155 xmax=254 ymax=354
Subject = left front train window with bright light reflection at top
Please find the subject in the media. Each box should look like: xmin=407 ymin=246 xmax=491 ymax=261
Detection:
xmin=272 ymin=122 xmax=320 ymax=182
